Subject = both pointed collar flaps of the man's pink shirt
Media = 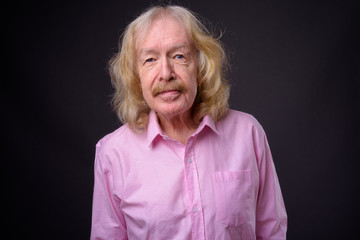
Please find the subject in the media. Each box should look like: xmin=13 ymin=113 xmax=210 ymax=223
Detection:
xmin=147 ymin=111 xmax=219 ymax=147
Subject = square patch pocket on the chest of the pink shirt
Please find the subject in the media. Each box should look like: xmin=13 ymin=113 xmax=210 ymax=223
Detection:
xmin=213 ymin=170 xmax=252 ymax=226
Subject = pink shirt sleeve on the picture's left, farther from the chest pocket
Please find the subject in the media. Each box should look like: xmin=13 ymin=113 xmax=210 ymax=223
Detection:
xmin=90 ymin=146 xmax=128 ymax=240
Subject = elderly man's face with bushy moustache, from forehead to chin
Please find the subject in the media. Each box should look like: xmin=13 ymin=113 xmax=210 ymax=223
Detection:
xmin=137 ymin=17 xmax=197 ymax=118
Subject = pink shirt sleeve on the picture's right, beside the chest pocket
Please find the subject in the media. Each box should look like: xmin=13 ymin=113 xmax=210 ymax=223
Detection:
xmin=256 ymin=133 xmax=287 ymax=240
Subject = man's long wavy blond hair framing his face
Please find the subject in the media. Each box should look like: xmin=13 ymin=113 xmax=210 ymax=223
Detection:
xmin=109 ymin=5 xmax=230 ymax=132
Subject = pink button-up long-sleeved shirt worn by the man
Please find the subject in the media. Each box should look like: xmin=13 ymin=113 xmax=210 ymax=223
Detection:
xmin=91 ymin=110 xmax=287 ymax=240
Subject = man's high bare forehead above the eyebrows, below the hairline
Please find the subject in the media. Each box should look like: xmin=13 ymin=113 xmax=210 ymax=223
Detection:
xmin=136 ymin=16 xmax=190 ymax=53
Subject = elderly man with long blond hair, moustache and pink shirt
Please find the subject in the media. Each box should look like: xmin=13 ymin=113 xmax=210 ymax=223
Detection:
xmin=91 ymin=6 xmax=287 ymax=240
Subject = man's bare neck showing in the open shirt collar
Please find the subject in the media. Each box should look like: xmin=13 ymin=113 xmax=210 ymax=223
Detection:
xmin=158 ymin=112 xmax=198 ymax=145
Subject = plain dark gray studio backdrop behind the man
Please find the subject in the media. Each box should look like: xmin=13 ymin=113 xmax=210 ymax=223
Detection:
xmin=6 ymin=0 xmax=360 ymax=240
